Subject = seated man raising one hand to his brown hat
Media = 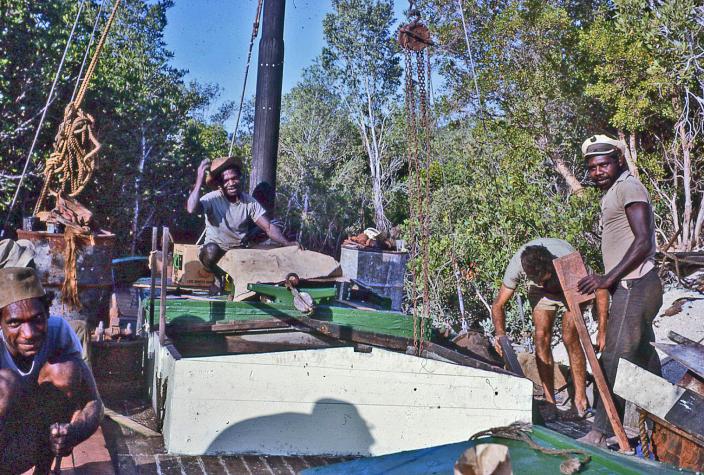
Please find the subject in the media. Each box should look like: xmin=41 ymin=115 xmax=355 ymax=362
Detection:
xmin=186 ymin=157 xmax=298 ymax=291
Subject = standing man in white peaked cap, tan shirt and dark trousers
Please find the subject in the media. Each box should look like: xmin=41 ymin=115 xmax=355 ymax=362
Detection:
xmin=578 ymin=135 xmax=662 ymax=445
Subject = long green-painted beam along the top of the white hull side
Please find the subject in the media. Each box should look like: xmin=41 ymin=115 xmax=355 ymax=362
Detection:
xmin=144 ymin=299 xmax=431 ymax=339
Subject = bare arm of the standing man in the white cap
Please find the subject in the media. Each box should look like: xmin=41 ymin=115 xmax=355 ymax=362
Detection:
xmin=577 ymin=201 xmax=652 ymax=294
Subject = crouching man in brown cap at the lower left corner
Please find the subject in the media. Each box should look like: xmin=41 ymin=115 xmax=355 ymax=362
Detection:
xmin=0 ymin=267 xmax=103 ymax=474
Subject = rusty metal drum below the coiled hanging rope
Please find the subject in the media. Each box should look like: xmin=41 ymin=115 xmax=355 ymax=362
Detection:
xmin=17 ymin=230 xmax=115 ymax=327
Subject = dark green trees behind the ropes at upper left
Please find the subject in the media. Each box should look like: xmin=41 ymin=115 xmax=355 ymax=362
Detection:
xmin=0 ymin=0 xmax=227 ymax=253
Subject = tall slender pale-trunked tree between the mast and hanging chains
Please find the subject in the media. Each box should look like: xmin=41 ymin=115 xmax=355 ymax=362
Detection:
xmin=321 ymin=0 xmax=403 ymax=231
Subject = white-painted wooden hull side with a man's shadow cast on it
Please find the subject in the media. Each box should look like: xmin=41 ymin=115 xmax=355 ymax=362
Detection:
xmin=150 ymin=334 xmax=533 ymax=456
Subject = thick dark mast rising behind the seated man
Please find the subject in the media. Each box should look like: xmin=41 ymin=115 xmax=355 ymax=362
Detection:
xmin=249 ymin=0 xmax=286 ymax=192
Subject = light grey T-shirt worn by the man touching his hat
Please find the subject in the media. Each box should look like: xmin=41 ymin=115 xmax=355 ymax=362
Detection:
xmin=200 ymin=190 xmax=265 ymax=250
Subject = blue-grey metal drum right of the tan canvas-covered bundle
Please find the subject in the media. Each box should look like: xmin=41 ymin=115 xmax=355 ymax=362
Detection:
xmin=340 ymin=246 xmax=408 ymax=311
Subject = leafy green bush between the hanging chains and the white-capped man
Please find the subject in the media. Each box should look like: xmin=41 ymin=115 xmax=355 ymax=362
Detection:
xmin=414 ymin=125 xmax=601 ymax=326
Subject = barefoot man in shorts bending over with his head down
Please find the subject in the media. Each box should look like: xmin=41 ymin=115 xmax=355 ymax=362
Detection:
xmin=491 ymin=238 xmax=609 ymax=415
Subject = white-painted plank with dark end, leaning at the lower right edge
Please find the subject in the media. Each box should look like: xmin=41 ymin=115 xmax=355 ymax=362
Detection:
xmin=614 ymin=359 xmax=704 ymax=441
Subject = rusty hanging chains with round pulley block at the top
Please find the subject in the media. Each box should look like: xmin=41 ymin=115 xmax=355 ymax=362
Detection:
xmin=399 ymin=7 xmax=432 ymax=355
